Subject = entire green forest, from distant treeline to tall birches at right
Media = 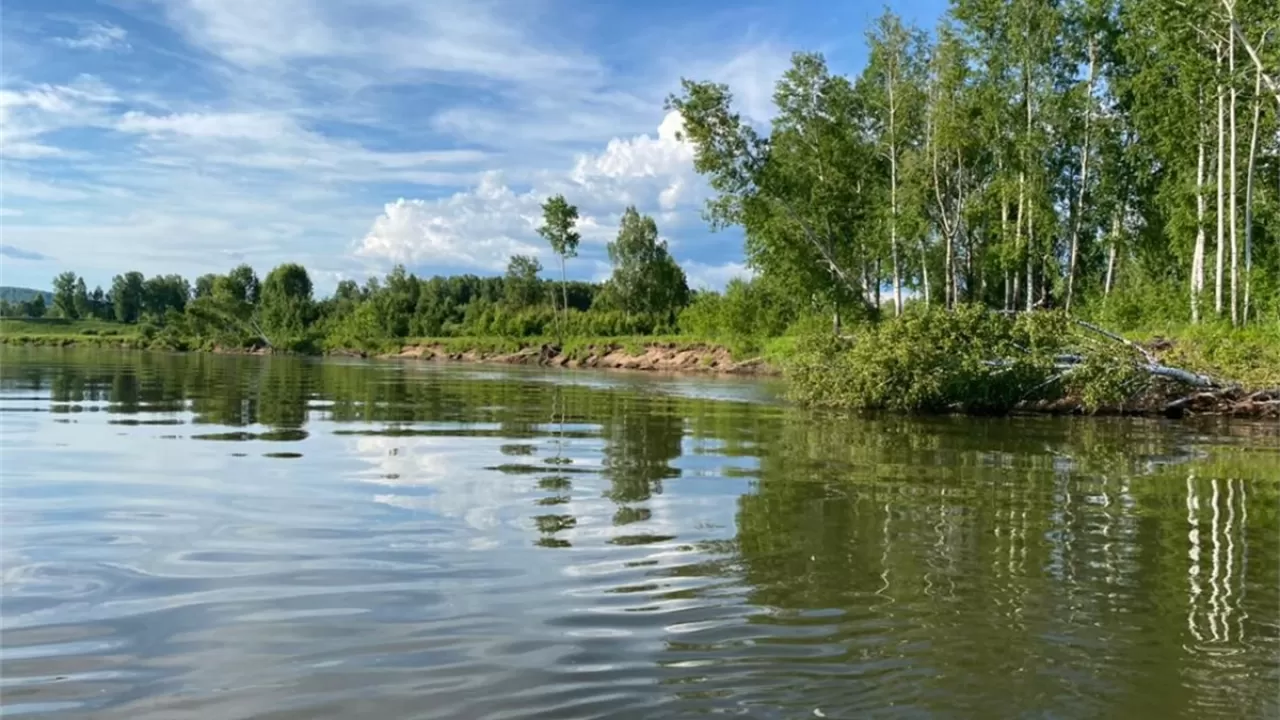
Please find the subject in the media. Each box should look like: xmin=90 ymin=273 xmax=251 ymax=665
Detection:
xmin=0 ymin=0 xmax=1280 ymax=406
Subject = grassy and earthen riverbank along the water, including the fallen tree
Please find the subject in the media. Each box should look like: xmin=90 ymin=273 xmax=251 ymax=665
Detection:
xmin=0 ymin=311 xmax=1280 ymax=419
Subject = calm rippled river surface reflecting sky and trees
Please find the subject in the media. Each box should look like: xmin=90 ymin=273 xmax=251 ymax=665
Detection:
xmin=0 ymin=348 xmax=1280 ymax=719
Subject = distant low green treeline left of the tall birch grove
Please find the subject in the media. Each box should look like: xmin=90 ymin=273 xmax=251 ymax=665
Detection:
xmin=0 ymin=203 xmax=819 ymax=351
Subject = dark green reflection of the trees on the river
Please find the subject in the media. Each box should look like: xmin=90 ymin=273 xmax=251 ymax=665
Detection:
xmin=0 ymin=354 xmax=1280 ymax=715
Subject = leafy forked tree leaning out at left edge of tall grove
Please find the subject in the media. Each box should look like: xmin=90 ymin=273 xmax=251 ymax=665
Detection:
xmin=667 ymin=53 xmax=879 ymax=327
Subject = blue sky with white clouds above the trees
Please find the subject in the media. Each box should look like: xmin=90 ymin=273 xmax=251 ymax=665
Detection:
xmin=0 ymin=0 xmax=945 ymax=293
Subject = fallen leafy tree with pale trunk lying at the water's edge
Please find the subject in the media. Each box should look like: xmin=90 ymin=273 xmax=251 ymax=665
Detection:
xmin=786 ymin=306 xmax=1264 ymax=415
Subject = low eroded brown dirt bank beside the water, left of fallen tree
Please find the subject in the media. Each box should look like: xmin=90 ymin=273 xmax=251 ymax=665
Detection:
xmin=383 ymin=343 xmax=778 ymax=375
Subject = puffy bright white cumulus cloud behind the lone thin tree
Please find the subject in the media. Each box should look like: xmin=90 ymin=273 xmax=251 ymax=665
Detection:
xmin=357 ymin=111 xmax=703 ymax=270
